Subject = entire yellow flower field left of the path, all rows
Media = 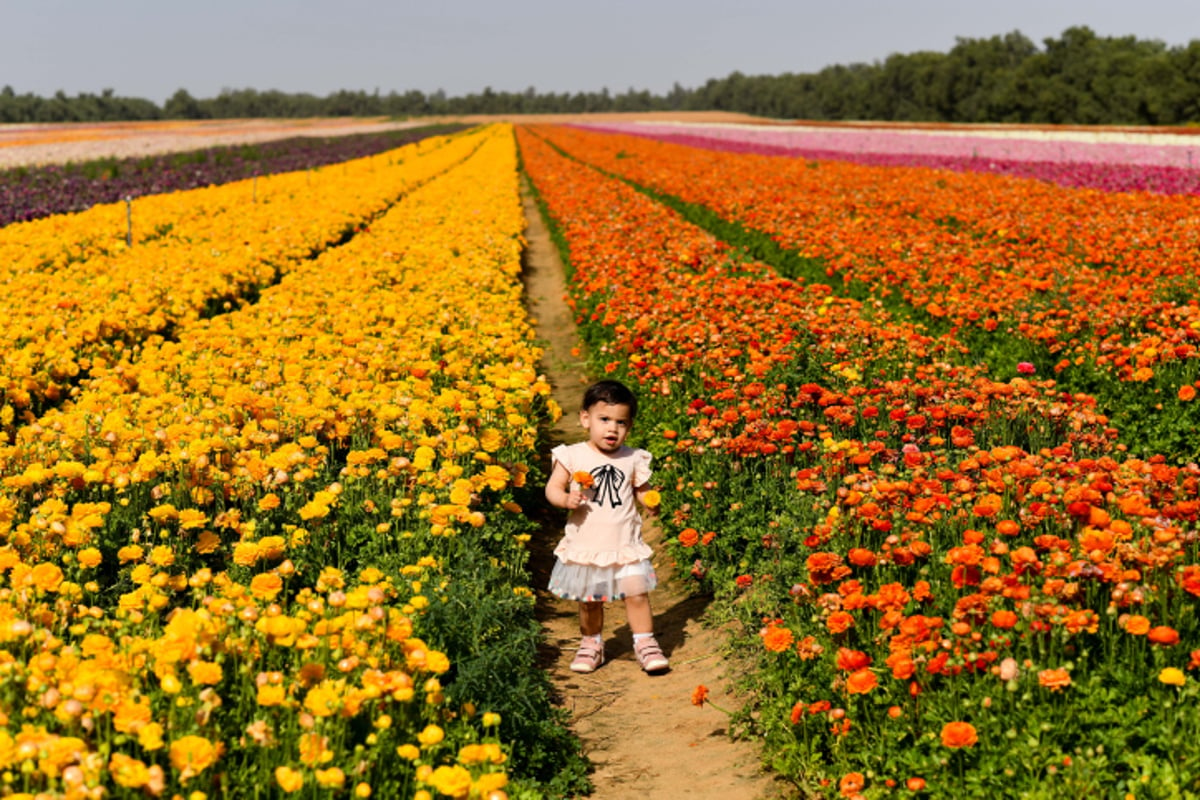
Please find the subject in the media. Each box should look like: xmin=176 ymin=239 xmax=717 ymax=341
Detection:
xmin=0 ymin=126 xmax=577 ymax=798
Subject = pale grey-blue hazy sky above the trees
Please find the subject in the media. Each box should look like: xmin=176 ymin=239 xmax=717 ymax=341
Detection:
xmin=0 ymin=0 xmax=1200 ymax=103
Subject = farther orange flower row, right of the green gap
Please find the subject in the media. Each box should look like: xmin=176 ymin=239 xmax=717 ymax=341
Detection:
xmin=535 ymin=123 xmax=1200 ymax=458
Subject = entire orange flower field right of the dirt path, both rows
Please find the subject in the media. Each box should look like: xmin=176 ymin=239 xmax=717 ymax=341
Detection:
xmin=517 ymin=126 xmax=1200 ymax=798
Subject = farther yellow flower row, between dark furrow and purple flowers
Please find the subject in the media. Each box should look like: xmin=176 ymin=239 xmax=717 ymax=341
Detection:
xmin=0 ymin=128 xmax=473 ymax=431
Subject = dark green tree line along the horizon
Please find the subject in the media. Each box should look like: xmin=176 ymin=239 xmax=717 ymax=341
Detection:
xmin=7 ymin=26 xmax=1200 ymax=125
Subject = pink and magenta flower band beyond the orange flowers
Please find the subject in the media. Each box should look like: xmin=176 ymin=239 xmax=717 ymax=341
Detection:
xmin=586 ymin=124 xmax=1200 ymax=194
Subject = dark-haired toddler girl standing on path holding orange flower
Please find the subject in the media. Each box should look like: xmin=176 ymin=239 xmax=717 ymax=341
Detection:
xmin=546 ymin=380 xmax=668 ymax=673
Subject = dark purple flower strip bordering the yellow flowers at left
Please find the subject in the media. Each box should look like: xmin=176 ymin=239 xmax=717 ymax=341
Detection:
xmin=0 ymin=125 xmax=467 ymax=225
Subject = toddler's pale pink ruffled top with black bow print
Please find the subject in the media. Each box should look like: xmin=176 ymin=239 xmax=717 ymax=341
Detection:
xmin=551 ymin=441 xmax=654 ymax=566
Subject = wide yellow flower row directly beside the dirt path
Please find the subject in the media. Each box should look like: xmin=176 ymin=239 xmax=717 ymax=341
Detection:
xmin=0 ymin=127 xmax=544 ymax=796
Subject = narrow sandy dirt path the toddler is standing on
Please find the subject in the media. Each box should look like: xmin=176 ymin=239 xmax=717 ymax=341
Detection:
xmin=524 ymin=181 xmax=785 ymax=800
